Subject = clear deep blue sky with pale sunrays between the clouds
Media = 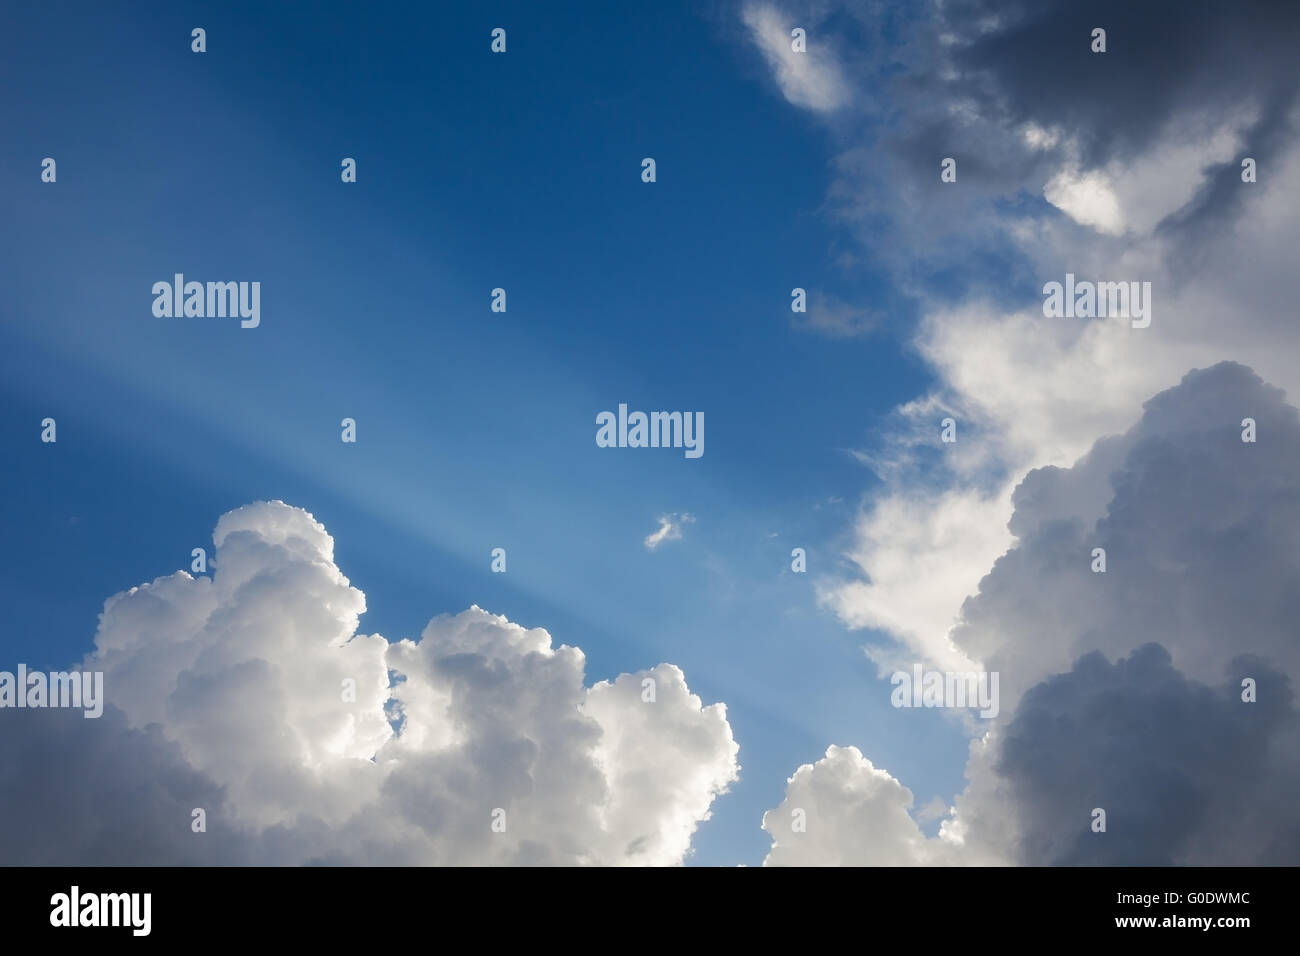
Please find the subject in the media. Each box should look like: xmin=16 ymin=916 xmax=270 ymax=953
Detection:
xmin=0 ymin=3 xmax=965 ymax=864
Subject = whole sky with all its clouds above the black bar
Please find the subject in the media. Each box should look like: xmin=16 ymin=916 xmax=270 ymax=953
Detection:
xmin=0 ymin=0 xmax=1300 ymax=866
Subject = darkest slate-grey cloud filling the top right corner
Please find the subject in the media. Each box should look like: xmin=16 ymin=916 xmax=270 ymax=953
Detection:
xmin=944 ymin=0 xmax=1300 ymax=165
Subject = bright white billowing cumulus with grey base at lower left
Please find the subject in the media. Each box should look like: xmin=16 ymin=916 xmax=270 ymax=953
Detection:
xmin=0 ymin=501 xmax=738 ymax=865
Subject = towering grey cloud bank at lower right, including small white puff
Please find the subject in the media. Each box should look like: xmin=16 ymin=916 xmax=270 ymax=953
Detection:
xmin=763 ymin=363 xmax=1300 ymax=865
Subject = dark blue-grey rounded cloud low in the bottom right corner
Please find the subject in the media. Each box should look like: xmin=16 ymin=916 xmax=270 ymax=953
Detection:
xmin=996 ymin=644 xmax=1300 ymax=866
